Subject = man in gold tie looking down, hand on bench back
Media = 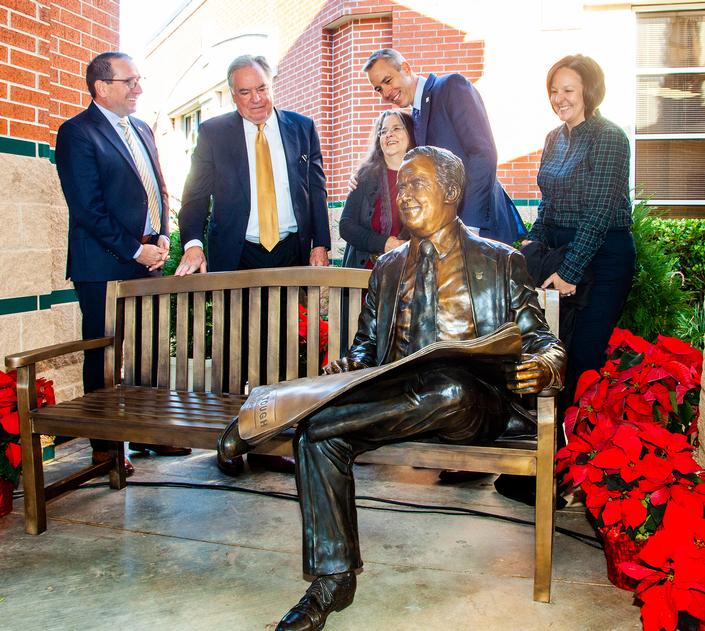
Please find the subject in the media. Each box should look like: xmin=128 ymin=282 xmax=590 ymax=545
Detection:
xmin=176 ymin=55 xmax=330 ymax=275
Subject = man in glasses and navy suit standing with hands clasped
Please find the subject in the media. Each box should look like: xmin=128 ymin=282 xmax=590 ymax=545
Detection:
xmin=56 ymin=52 xmax=190 ymax=474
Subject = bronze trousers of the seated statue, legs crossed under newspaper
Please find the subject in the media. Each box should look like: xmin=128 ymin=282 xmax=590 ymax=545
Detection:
xmin=294 ymin=365 xmax=507 ymax=576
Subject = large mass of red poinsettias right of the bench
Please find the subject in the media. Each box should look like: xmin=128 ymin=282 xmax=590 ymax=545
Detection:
xmin=556 ymin=329 xmax=705 ymax=629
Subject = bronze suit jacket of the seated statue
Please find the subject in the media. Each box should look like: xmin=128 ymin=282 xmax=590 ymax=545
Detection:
xmin=347 ymin=221 xmax=565 ymax=375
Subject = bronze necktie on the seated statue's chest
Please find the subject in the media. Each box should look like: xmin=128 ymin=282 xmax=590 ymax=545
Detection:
xmin=408 ymin=239 xmax=438 ymax=355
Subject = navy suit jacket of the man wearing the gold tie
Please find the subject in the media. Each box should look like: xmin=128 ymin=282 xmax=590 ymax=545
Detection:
xmin=179 ymin=110 xmax=330 ymax=272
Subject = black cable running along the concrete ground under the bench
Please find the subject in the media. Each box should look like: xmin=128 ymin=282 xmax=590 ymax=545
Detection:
xmin=13 ymin=481 xmax=602 ymax=550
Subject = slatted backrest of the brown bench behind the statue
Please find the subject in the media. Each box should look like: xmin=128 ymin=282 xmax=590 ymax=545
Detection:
xmin=106 ymin=267 xmax=558 ymax=394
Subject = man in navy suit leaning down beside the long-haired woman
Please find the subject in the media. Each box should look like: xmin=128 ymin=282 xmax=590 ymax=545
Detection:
xmin=362 ymin=48 xmax=526 ymax=244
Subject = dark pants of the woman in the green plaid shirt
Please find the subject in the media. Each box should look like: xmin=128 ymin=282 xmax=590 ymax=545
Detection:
xmin=546 ymin=226 xmax=636 ymax=407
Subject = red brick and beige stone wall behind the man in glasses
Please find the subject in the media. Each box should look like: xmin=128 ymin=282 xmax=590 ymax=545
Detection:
xmin=0 ymin=0 xmax=119 ymax=400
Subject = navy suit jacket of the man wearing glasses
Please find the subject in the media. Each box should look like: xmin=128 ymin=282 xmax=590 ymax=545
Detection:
xmin=56 ymin=103 xmax=169 ymax=281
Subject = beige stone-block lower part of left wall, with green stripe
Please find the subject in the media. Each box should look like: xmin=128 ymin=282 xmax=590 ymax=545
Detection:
xmin=0 ymin=154 xmax=81 ymax=399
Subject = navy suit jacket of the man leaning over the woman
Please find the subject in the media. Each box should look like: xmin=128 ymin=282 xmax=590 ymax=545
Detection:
xmin=414 ymin=74 xmax=526 ymax=244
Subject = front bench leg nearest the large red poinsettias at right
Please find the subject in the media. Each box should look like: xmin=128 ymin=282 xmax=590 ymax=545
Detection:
xmin=534 ymin=397 xmax=556 ymax=603
